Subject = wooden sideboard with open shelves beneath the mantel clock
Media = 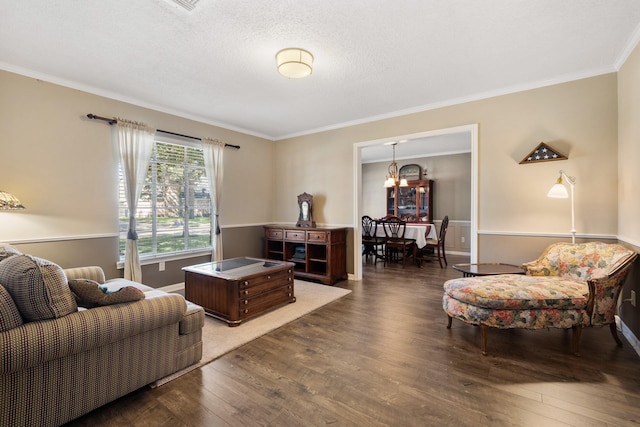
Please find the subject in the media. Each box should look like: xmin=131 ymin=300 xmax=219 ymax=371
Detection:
xmin=264 ymin=225 xmax=347 ymax=285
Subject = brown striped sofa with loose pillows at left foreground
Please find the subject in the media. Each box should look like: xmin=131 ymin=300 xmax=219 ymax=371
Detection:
xmin=0 ymin=245 xmax=204 ymax=427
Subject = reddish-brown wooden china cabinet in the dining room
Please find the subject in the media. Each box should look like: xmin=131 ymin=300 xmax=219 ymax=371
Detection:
xmin=386 ymin=179 xmax=433 ymax=223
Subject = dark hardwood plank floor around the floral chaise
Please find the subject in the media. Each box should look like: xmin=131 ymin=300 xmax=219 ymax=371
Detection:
xmin=69 ymin=255 xmax=640 ymax=426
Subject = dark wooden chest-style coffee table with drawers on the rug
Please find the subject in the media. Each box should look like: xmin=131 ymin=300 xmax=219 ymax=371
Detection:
xmin=182 ymin=257 xmax=296 ymax=326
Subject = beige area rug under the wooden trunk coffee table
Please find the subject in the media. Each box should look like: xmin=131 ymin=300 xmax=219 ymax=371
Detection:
xmin=151 ymin=280 xmax=351 ymax=387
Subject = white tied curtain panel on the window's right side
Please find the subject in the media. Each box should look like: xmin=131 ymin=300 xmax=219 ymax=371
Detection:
xmin=202 ymin=138 xmax=224 ymax=261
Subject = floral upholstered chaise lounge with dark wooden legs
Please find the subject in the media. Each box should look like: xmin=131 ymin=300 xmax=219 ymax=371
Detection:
xmin=442 ymin=242 xmax=637 ymax=356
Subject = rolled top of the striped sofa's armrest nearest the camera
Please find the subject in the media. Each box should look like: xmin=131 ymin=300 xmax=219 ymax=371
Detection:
xmin=0 ymin=294 xmax=187 ymax=375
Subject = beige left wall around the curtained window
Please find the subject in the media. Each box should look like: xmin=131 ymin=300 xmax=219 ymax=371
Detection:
xmin=0 ymin=71 xmax=274 ymax=284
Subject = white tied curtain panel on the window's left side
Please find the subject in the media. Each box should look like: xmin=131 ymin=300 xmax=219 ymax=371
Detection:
xmin=116 ymin=118 xmax=154 ymax=283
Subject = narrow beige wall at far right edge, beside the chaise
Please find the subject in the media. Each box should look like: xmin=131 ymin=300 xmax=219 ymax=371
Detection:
xmin=618 ymin=41 xmax=640 ymax=338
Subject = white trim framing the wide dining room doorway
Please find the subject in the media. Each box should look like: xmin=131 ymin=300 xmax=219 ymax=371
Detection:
xmin=353 ymin=123 xmax=478 ymax=280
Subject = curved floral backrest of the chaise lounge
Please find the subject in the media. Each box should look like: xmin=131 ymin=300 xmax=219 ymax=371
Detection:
xmin=524 ymin=242 xmax=634 ymax=280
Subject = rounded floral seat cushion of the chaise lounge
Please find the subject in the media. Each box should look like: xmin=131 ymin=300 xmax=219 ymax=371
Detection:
xmin=444 ymin=274 xmax=589 ymax=310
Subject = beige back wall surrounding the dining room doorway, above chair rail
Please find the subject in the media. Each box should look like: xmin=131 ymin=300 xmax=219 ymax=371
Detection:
xmin=274 ymin=74 xmax=618 ymax=258
